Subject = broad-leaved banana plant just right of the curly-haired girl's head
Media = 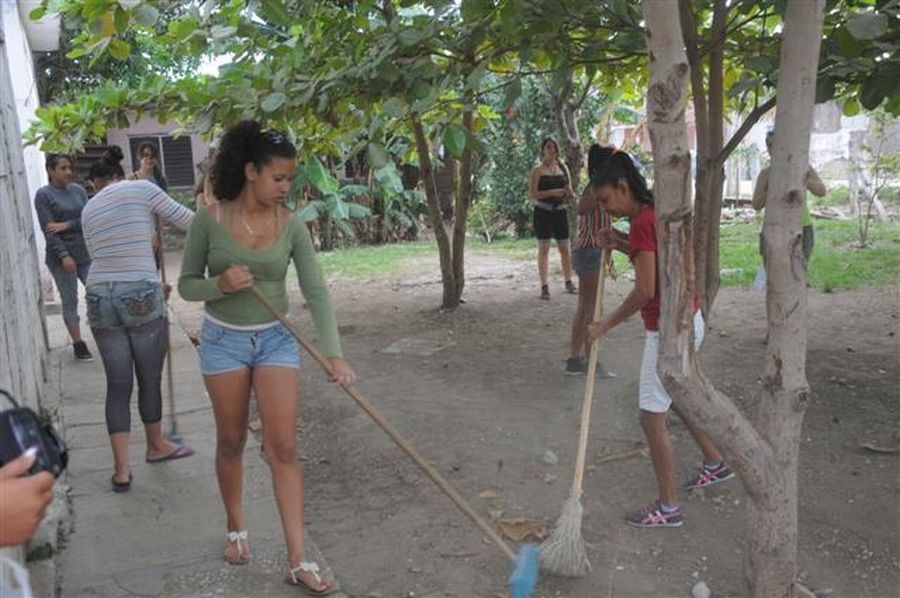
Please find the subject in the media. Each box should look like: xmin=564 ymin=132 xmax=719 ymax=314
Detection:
xmin=291 ymin=156 xmax=372 ymax=251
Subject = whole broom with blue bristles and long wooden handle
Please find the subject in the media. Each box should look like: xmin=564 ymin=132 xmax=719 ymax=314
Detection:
xmin=250 ymin=285 xmax=538 ymax=598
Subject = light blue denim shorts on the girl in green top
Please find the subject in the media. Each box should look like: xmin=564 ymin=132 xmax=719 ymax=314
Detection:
xmin=200 ymin=318 xmax=300 ymax=376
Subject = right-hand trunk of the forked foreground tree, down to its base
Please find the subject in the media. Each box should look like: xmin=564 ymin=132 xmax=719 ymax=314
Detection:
xmin=750 ymin=0 xmax=825 ymax=596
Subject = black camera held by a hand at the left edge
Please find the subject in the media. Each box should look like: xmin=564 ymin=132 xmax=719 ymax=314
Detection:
xmin=0 ymin=388 xmax=69 ymax=478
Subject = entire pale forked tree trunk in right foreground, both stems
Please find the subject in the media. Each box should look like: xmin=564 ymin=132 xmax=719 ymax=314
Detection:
xmin=643 ymin=0 xmax=825 ymax=598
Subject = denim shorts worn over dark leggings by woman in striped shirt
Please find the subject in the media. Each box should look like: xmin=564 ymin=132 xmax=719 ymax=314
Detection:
xmin=84 ymin=280 xmax=166 ymax=328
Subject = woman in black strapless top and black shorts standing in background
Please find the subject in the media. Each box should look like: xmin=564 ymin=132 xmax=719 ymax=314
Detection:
xmin=528 ymin=137 xmax=578 ymax=299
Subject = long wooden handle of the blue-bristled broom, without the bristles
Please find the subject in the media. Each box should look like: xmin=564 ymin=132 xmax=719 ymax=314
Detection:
xmin=250 ymin=284 xmax=516 ymax=559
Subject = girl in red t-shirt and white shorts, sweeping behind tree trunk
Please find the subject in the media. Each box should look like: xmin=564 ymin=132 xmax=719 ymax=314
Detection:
xmin=589 ymin=152 xmax=734 ymax=527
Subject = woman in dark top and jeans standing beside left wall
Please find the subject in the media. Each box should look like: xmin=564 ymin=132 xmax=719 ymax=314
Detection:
xmin=34 ymin=154 xmax=93 ymax=361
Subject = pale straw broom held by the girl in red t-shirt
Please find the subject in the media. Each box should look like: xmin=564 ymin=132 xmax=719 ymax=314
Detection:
xmin=540 ymin=251 xmax=606 ymax=577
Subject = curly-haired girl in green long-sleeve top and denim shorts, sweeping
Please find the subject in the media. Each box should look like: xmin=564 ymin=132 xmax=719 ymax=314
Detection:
xmin=178 ymin=121 xmax=356 ymax=596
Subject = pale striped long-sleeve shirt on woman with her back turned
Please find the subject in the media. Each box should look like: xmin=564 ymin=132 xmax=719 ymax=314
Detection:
xmin=81 ymin=181 xmax=194 ymax=286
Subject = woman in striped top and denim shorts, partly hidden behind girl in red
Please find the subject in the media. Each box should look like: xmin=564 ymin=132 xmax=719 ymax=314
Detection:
xmin=566 ymin=143 xmax=614 ymax=376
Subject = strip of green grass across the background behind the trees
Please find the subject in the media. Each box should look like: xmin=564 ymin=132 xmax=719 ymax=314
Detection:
xmin=319 ymin=220 xmax=900 ymax=292
